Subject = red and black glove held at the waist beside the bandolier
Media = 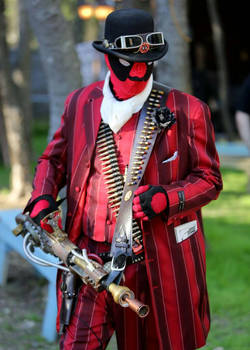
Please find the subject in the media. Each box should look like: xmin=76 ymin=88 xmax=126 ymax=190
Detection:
xmin=133 ymin=185 xmax=168 ymax=221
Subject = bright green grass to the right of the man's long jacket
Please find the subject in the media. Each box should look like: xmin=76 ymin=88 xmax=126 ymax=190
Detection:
xmin=203 ymin=168 xmax=250 ymax=350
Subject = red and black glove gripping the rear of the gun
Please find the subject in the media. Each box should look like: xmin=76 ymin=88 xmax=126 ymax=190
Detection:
xmin=25 ymin=194 xmax=62 ymax=232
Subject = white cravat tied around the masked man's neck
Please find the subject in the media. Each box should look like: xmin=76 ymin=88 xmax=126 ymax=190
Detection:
xmin=101 ymin=71 xmax=153 ymax=133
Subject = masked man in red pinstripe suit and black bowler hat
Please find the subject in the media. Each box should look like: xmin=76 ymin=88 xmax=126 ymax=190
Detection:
xmin=27 ymin=9 xmax=222 ymax=350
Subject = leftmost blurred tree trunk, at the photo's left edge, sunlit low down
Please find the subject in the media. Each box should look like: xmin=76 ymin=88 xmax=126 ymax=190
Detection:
xmin=0 ymin=0 xmax=31 ymax=198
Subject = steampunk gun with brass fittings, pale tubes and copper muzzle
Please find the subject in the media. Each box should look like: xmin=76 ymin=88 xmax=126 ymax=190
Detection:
xmin=13 ymin=210 xmax=149 ymax=317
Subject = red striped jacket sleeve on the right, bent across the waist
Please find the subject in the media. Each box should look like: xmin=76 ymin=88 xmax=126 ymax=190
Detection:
xmin=162 ymin=101 xmax=222 ymax=218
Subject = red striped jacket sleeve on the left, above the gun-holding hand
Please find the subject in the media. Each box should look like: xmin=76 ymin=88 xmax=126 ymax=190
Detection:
xmin=29 ymin=94 xmax=72 ymax=203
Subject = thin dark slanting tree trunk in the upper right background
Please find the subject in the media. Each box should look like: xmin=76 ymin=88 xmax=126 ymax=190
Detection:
xmin=207 ymin=0 xmax=234 ymax=139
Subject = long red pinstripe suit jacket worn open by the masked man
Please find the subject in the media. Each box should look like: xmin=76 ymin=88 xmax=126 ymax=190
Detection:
xmin=29 ymin=82 xmax=222 ymax=350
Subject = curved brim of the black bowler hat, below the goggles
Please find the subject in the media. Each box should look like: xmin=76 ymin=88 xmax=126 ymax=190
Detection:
xmin=92 ymin=40 xmax=168 ymax=62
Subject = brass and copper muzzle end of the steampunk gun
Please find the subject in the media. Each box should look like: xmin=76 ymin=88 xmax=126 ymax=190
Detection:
xmin=108 ymin=283 xmax=149 ymax=318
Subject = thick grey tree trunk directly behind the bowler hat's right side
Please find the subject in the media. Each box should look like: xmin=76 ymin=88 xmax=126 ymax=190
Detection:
xmin=155 ymin=0 xmax=191 ymax=93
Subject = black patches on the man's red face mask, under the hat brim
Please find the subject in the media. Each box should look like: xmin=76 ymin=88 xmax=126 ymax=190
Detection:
xmin=108 ymin=55 xmax=154 ymax=81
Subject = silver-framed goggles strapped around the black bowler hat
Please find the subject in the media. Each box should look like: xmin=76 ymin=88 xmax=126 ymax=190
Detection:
xmin=103 ymin=32 xmax=164 ymax=50
